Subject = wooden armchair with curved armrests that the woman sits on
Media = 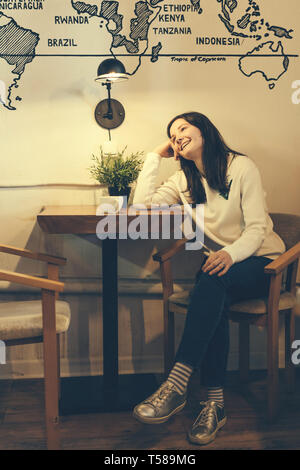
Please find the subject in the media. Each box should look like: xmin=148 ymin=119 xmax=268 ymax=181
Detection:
xmin=153 ymin=214 xmax=300 ymax=421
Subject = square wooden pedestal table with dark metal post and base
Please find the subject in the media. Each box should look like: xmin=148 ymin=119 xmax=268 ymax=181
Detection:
xmin=37 ymin=206 xmax=183 ymax=414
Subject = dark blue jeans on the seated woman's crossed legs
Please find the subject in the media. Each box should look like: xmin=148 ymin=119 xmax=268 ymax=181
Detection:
xmin=176 ymin=256 xmax=272 ymax=387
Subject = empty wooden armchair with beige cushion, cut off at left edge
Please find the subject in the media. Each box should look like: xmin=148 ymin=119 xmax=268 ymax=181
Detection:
xmin=0 ymin=245 xmax=70 ymax=450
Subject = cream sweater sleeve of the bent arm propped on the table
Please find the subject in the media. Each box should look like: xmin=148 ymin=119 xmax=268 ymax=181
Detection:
xmin=133 ymin=152 xmax=180 ymax=205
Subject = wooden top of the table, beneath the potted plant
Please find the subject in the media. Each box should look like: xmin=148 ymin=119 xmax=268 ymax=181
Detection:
xmin=37 ymin=205 xmax=182 ymax=234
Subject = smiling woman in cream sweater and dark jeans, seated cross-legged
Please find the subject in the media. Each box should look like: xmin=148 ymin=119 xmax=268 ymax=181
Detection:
xmin=133 ymin=112 xmax=285 ymax=445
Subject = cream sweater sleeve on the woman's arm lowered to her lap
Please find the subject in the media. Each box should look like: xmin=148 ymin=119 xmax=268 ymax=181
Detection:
xmin=223 ymin=159 xmax=267 ymax=263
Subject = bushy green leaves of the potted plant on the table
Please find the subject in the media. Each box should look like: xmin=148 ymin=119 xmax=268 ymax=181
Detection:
xmin=89 ymin=146 xmax=144 ymax=192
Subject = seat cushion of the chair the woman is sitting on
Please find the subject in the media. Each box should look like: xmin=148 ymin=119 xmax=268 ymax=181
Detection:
xmin=169 ymin=291 xmax=296 ymax=314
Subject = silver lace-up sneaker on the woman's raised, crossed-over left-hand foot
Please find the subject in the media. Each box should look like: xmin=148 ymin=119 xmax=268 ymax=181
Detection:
xmin=133 ymin=381 xmax=186 ymax=424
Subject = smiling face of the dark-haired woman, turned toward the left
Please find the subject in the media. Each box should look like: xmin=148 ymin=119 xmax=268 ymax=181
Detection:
xmin=170 ymin=118 xmax=204 ymax=160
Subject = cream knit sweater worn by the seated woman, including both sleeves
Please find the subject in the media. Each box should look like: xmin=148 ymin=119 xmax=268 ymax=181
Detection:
xmin=133 ymin=153 xmax=285 ymax=263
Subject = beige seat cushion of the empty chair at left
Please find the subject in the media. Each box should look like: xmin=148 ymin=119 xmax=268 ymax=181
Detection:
xmin=0 ymin=300 xmax=71 ymax=341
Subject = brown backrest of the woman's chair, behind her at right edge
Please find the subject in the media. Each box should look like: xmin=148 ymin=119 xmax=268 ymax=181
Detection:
xmin=270 ymin=213 xmax=300 ymax=250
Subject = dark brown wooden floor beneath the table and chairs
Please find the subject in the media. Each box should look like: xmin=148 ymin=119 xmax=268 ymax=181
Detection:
xmin=0 ymin=369 xmax=300 ymax=451
